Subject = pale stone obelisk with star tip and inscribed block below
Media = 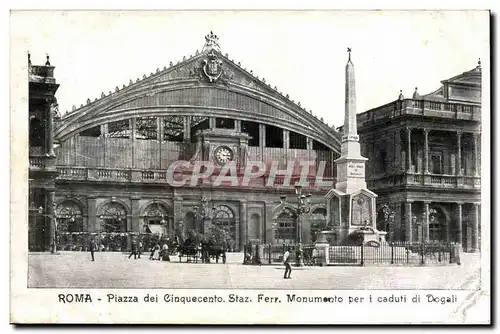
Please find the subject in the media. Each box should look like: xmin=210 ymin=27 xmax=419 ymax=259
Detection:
xmin=335 ymin=48 xmax=368 ymax=194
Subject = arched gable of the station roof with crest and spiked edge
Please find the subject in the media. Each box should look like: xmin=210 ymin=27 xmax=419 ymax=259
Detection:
xmin=56 ymin=33 xmax=340 ymax=149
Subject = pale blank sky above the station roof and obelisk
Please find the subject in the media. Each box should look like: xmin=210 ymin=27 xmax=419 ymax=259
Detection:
xmin=11 ymin=11 xmax=489 ymax=127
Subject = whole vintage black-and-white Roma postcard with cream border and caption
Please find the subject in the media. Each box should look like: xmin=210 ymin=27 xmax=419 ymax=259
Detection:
xmin=10 ymin=10 xmax=491 ymax=324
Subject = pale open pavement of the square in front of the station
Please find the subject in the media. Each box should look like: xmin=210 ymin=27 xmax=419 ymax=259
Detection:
xmin=28 ymin=252 xmax=480 ymax=290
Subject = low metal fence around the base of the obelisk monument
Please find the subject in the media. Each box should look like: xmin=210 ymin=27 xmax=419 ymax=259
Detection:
xmin=245 ymin=242 xmax=458 ymax=266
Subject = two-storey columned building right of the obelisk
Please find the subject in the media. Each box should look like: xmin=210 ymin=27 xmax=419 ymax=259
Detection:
xmin=357 ymin=62 xmax=481 ymax=251
